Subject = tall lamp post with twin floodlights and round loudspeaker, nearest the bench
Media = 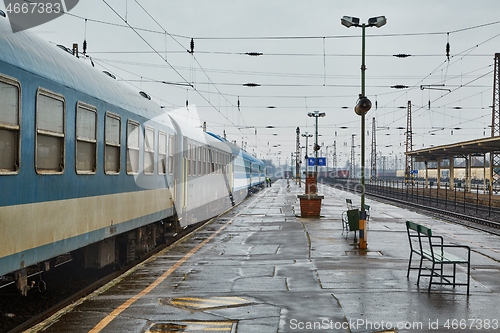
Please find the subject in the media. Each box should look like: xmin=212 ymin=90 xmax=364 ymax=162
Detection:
xmin=340 ymin=16 xmax=387 ymax=249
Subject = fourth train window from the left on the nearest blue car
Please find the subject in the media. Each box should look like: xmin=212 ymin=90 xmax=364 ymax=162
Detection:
xmin=104 ymin=112 xmax=121 ymax=174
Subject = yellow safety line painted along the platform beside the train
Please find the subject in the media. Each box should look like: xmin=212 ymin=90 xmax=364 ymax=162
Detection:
xmin=89 ymin=187 xmax=268 ymax=333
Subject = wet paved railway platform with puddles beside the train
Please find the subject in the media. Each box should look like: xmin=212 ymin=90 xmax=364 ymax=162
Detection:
xmin=27 ymin=180 xmax=500 ymax=333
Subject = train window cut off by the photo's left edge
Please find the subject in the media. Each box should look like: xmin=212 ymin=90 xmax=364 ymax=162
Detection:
xmin=0 ymin=76 xmax=21 ymax=175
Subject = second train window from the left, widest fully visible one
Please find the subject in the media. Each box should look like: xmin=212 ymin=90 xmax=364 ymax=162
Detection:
xmin=35 ymin=89 xmax=65 ymax=173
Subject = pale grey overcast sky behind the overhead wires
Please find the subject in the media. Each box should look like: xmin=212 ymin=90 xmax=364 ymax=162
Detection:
xmin=0 ymin=0 xmax=500 ymax=167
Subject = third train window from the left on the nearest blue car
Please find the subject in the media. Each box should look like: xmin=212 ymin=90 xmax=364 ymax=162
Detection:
xmin=76 ymin=102 xmax=97 ymax=174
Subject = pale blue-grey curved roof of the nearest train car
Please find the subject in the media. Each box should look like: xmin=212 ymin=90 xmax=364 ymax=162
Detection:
xmin=0 ymin=17 xmax=168 ymax=122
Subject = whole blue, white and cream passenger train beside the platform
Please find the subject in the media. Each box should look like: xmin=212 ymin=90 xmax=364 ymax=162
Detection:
xmin=0 ymin=17 xmax=265 ymax=295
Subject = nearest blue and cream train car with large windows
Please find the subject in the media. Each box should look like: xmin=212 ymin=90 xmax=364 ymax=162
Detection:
xmin=0 ymin=18 xmax=180 ymax=293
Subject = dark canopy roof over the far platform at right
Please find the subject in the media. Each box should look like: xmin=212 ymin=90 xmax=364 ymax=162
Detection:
xmin=406 ymin=136 xmax=500 ymax=162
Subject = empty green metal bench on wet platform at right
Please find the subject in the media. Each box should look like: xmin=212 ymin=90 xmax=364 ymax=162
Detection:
xmin=406 ymin=221 xmax=470 ymax=295
